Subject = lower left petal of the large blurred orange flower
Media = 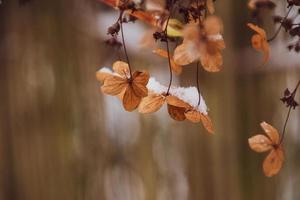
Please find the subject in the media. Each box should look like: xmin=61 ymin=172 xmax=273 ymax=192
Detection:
xmin=173 ymin=41 xmax=199 ymax=65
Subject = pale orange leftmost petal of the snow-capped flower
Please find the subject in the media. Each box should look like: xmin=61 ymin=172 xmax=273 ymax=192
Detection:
xmin=139 ymin=94 xmax=166 ymax=114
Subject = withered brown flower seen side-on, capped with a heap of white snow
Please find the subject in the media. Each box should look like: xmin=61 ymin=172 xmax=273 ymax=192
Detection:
xmin=138 ymin=78 xmax=214 ymax=133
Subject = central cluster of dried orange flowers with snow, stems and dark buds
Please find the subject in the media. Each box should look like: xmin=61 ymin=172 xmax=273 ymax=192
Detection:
xmin=96 ymin=0 xmax=225 ymax=133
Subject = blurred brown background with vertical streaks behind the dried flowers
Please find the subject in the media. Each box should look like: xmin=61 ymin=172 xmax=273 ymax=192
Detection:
xmin=0 ymin=0 xmax=300 ymax=200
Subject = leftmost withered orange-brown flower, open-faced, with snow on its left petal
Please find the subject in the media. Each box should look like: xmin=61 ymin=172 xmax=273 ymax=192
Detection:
xmin=96 ymin=61 xmax=149 ymax=111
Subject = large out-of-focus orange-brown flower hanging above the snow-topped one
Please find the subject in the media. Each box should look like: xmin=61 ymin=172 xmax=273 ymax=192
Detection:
xmin=174 ymin=16 xmax=225 ymax=72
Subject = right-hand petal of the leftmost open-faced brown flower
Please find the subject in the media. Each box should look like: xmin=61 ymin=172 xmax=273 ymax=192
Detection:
xmin=131 ymin=71 xmax=149 ymax=97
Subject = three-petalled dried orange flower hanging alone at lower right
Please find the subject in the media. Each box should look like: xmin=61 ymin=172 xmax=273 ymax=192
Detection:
xmin=248 ymin=122 xmax=284 ymax=177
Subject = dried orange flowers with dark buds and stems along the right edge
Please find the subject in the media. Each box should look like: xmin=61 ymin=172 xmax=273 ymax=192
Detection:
xmin=247 ymin=0 xmax=300 ymax=177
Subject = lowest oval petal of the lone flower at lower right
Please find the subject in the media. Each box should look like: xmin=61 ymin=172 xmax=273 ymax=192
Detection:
xmin=263 ymin=147 xmax=284 ymax=177
